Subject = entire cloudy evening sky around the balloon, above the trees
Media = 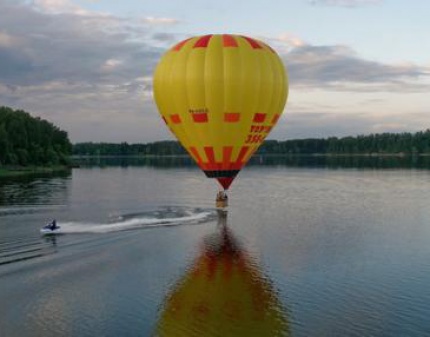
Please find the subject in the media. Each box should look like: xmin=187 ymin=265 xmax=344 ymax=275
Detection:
xmin=0 ymin=0 xmax=430 ymax=143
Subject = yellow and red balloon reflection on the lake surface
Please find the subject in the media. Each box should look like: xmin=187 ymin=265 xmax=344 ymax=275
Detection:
xmin=155 ymin=213 xmax=290 ymax=337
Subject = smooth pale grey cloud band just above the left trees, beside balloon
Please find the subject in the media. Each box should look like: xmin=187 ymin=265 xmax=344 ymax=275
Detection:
xmin=0 ymin=83 xmax=171 ymax=142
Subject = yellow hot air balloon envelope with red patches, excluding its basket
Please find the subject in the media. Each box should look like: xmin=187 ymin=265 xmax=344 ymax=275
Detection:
xmin=154 ymin=34 xmax=288 ymax=203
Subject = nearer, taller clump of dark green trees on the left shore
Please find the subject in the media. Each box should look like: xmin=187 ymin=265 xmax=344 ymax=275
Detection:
xmin=0 ymin=106 xmax=72 ymax=166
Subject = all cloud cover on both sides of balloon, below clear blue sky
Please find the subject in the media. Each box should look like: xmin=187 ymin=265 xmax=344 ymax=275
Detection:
xmin=0 ymin=0 xmax=429 ymax=142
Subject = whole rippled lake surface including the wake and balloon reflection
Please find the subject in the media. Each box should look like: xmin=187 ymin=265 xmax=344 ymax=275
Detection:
xmin=0 ymin=159 xmax=430 ymax=337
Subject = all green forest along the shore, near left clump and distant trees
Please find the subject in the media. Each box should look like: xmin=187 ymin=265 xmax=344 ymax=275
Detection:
xmin=0 ymin=107 xmax=430 ymax=167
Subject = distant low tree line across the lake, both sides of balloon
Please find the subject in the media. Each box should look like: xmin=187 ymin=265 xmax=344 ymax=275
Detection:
xmin=73 ymin=130 xmax=430 ymax=156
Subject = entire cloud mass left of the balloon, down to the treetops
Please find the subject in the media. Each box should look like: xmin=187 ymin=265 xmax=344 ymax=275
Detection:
xmin=0 ymin=1 xmax=168 ymax=141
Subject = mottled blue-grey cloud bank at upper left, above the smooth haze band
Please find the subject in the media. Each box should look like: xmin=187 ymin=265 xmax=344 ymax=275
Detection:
xmin=0 ymin=4 xmax=160 ymax=86
